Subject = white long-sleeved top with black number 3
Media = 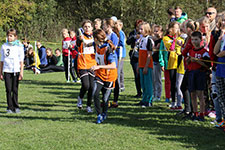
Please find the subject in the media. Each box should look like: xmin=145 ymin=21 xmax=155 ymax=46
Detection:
xmin=1 ymin=43 xmax=24 ymax=73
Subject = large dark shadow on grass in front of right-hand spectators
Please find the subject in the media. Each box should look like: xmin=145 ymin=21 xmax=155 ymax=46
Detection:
xmin=74 ymin=100 xmax=225 ymax=150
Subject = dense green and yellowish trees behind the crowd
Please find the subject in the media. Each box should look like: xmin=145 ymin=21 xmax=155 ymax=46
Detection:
xmin=0 ymin=0 xmax=225 ymax=41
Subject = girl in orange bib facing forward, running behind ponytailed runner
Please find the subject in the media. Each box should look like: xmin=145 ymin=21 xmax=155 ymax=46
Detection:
xmin=77 ymin=20 xmax=96 ymax=113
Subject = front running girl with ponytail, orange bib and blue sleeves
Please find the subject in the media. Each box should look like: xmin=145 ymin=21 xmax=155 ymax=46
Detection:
xmin=91 ymin=29 xmax=118 ymax=123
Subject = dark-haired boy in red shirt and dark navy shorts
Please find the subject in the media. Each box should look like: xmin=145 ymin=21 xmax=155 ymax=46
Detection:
xmin=187 ymin=31 xmax=210 ymax=121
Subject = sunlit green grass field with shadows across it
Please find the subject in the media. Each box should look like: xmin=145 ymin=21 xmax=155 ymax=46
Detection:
xmin=0 ymin=42 xmax=225 ymax=150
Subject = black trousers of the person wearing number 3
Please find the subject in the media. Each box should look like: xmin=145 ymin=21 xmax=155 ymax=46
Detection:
xmin=4 ymin=73 xmax=19 ymax=111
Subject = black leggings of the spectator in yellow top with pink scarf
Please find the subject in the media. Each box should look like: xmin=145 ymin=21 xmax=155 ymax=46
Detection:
xmin=169 ymin=69 xmax=177 ymax=102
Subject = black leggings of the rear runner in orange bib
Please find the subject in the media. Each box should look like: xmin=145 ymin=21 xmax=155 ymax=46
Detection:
xmin=79 ymin=69 xmax=95 ymax=106
